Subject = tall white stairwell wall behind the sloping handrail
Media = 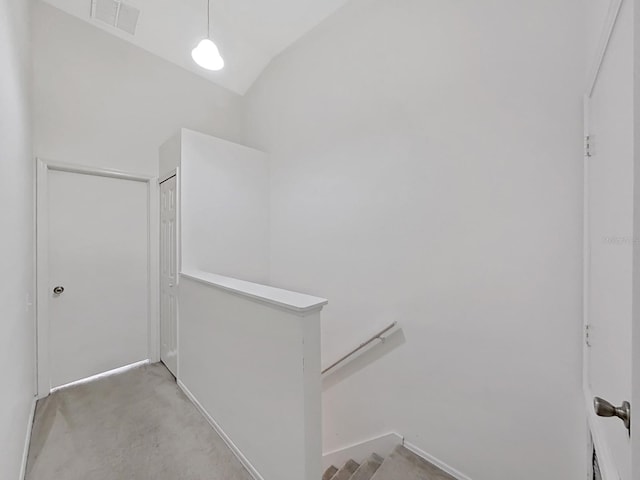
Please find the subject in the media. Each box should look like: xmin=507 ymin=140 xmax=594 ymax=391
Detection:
xmin=246 ymin=0 xmax=586 ymax=480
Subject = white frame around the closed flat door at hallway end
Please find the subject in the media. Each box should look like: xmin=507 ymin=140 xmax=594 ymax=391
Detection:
xmin=36 ymin=158 xmax=160 ymax=398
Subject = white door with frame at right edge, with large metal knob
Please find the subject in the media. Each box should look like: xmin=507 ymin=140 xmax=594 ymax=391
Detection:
xmin=584 ymin=0 xmax=640 ymax=480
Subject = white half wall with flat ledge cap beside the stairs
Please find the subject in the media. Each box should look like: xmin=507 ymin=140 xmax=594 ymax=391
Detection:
xmin=178 ymin=270 xmax=325 ymax=480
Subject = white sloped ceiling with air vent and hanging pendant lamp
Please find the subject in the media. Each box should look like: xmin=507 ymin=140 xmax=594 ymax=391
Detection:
xmin=44 ymin=0 xmax=348 ymax=95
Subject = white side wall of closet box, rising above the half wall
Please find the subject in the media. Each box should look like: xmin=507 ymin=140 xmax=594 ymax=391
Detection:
xmin=178 ymin=129 xmax=269 ymax=283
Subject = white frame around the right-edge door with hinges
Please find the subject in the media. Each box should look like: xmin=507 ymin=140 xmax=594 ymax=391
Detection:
xmin=582 ymin=0 xmax=623 ymax=480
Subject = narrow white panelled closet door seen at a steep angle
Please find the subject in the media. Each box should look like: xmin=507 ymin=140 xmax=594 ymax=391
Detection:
xmin=160 ymin=176 xmax=178 ymax=377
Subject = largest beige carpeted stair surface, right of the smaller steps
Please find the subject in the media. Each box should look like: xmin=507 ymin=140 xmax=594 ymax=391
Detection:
xmin=371 ymin=445 xmax=455 ymax=480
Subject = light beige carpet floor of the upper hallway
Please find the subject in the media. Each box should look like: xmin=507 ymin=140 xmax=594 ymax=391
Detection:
xmin=26 ymin=364 xmax=251 ymax=480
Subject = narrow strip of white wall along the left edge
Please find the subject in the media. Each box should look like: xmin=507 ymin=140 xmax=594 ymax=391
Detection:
xmin=0 ymin=0 xmax=35 ymax=480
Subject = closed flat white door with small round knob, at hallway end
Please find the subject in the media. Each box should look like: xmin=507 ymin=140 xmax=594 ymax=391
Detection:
xmin=47 ymin=170 xmax=149 ymax=387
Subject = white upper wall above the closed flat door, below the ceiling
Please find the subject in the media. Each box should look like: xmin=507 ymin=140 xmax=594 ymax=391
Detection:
xmin=34 ymin=2 xmax=244 ymax=174
